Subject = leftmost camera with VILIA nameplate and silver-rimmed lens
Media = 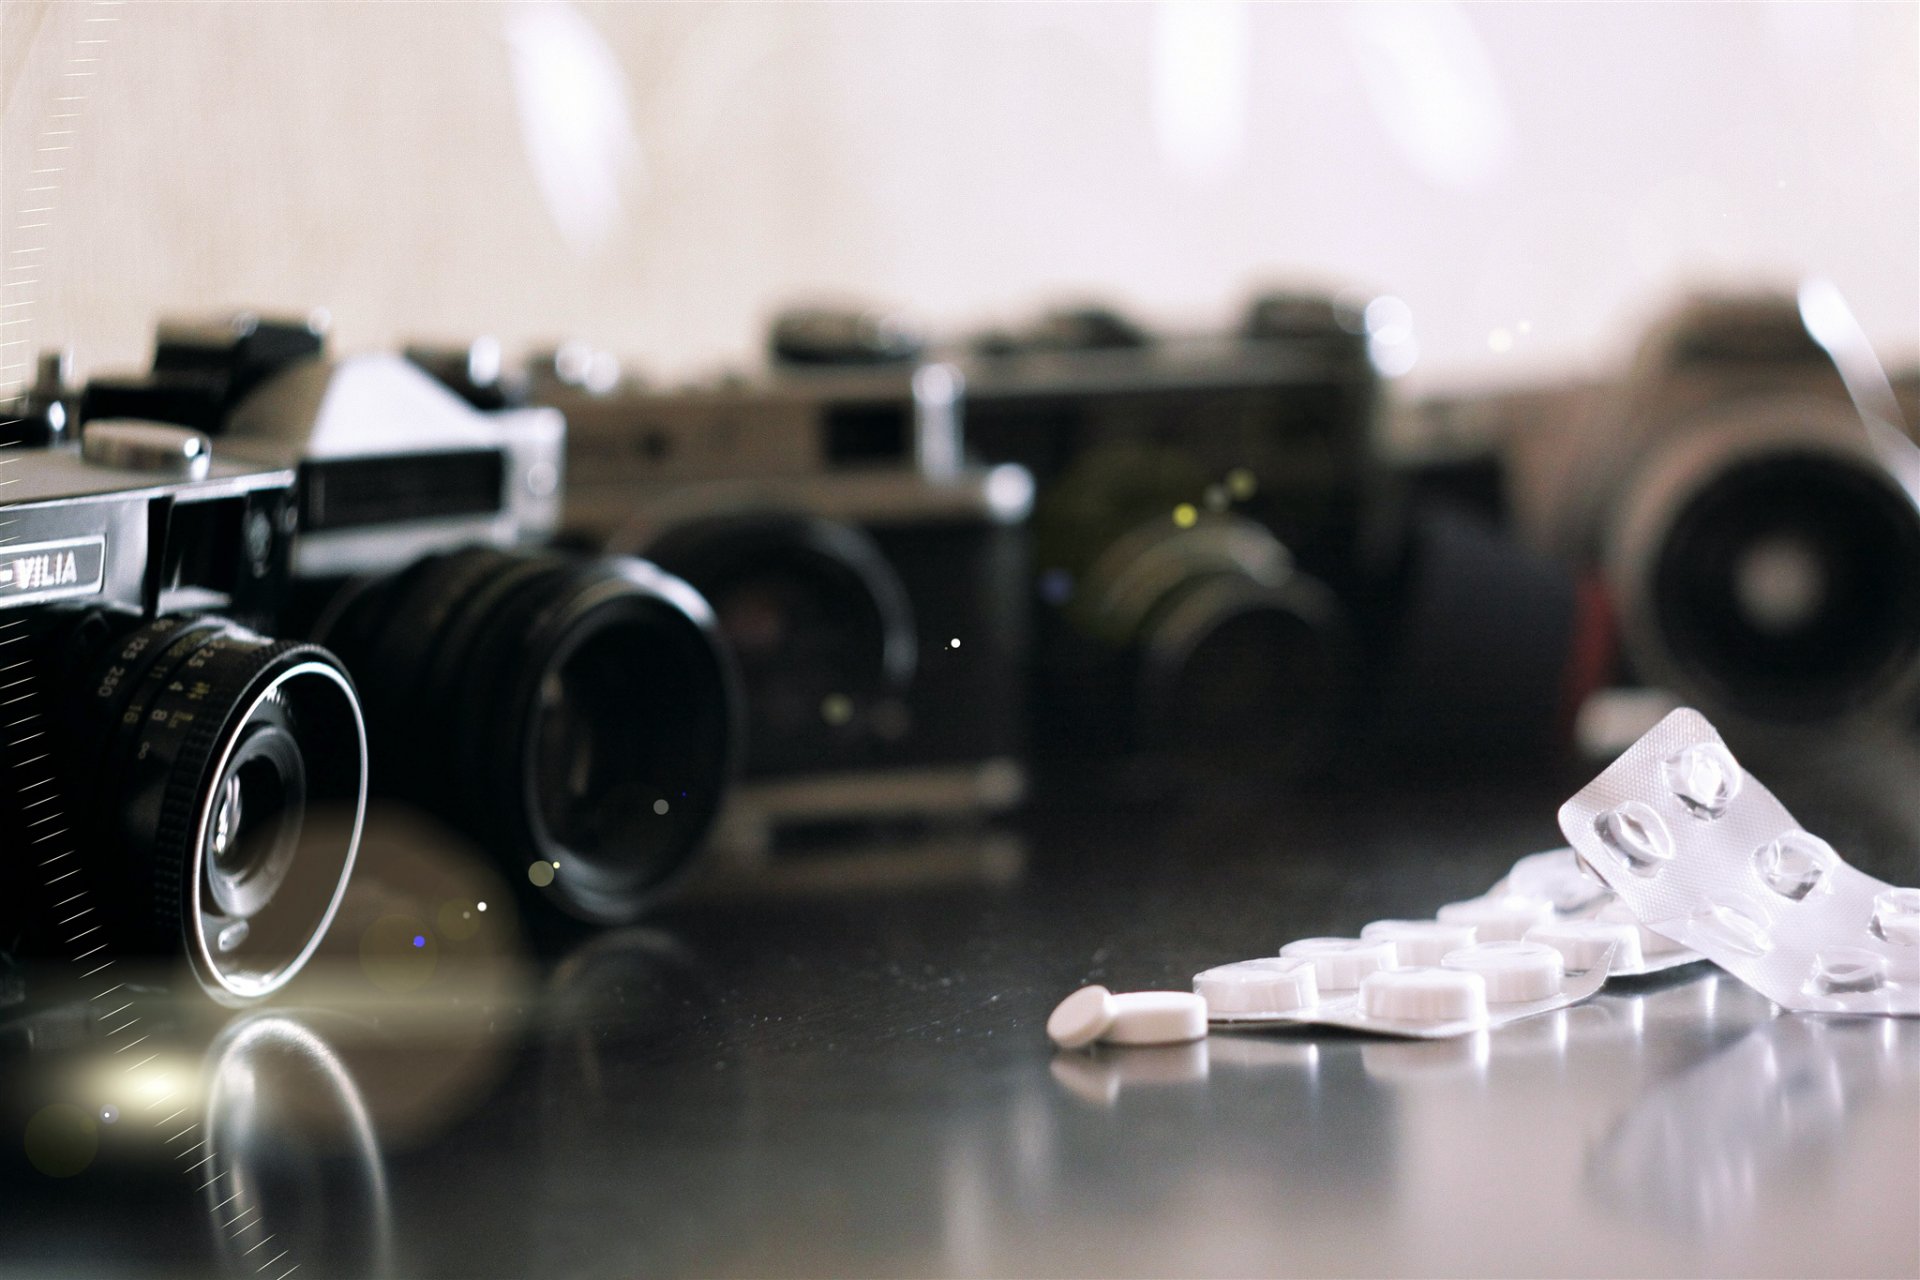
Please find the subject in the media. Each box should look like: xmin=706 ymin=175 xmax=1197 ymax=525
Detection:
xmin=0 ymin=365 xmax=367 ymax=1000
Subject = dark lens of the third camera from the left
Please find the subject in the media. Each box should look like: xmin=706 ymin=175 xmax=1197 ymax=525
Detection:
xmin=647 ymin=514 xmax=918 ymax=773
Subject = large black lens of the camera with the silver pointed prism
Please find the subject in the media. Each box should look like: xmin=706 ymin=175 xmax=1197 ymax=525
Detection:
xmin=317 ymin=547 xmax=739 ymax=925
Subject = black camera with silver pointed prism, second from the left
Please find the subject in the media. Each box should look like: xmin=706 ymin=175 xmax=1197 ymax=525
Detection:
xmin=83 ymin=317 xmax=735 ymax=923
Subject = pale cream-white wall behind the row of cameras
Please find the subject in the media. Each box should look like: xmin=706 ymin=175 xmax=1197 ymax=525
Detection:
xmin=0 ymin=0 xmax=1920 ymax=395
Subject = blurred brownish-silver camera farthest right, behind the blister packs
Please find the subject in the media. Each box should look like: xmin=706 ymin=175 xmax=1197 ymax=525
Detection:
xmin=1423 ymin=282 xmax=1920 ymax=741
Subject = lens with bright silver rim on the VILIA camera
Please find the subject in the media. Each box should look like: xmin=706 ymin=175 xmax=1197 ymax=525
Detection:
xmin=75 ymin=614 xmax=367 ymax=998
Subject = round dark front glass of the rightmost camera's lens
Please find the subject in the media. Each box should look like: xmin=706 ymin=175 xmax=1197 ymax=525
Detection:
xmin=1651 ymin=451 xmax=1920 ymax=720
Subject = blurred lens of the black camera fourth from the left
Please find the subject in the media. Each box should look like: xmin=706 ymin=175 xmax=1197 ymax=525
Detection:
xmin=1075 ymin=516 xmax=1348 ymax=764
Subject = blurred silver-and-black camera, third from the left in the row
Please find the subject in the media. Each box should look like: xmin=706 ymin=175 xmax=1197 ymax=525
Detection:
xmin=503 ymin=339 xmax=1031 ymax=852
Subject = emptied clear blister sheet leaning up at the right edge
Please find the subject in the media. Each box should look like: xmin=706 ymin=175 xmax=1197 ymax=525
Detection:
xmin=1559 ymin=708 xmax=1920 ymax=1015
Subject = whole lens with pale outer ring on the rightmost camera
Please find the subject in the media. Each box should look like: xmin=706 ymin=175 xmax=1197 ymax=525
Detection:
xmin=1607 ymin=399 xmax=1920 ymax=723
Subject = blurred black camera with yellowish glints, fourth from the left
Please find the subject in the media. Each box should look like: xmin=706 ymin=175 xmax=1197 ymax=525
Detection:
xmin=929 ymin=297 xmax=1380 ymax=777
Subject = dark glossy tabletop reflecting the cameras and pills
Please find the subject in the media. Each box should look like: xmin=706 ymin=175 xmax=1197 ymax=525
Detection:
xmin=0 ymin=789 xmax=1920 ymax=1280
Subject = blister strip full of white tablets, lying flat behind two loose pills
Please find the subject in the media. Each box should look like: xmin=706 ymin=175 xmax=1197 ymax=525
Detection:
xmin=1194 ymin=940 xmax=1609 ymax=1040
